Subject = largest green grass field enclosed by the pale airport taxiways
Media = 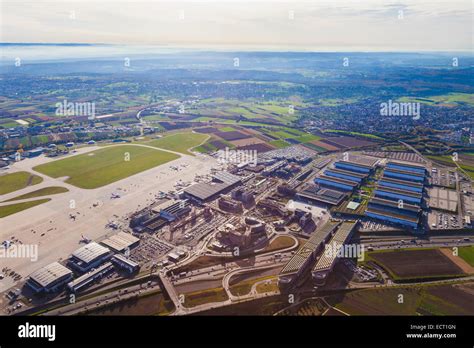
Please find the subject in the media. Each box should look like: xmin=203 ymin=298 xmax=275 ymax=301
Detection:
xmin=34 ymin=145 xmax=179 ymax=189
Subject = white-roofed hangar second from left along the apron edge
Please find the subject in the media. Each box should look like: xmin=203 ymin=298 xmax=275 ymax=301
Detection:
xmin=68 ymin=242 xmax=112 ymax=273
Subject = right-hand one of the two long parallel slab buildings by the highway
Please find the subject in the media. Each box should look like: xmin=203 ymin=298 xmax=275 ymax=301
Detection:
xmin=311 ymin=221 xmax=357 ymax=286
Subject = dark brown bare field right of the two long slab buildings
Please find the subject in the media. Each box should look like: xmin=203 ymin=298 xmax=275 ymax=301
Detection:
xmin=368 ymin=249 xmax=465 ymax=280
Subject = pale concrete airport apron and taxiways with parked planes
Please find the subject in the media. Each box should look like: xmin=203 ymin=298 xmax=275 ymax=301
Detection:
xmin=0 ymin=144 xmax=216 ymax=292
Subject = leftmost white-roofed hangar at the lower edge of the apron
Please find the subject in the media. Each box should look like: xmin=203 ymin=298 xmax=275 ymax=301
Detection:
xmin=26 ymin=262 xmax=72 ymax=293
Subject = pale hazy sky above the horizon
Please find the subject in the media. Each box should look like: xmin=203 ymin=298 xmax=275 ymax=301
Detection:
xmin=0 ymin=0 xmax=473 ymax=51
